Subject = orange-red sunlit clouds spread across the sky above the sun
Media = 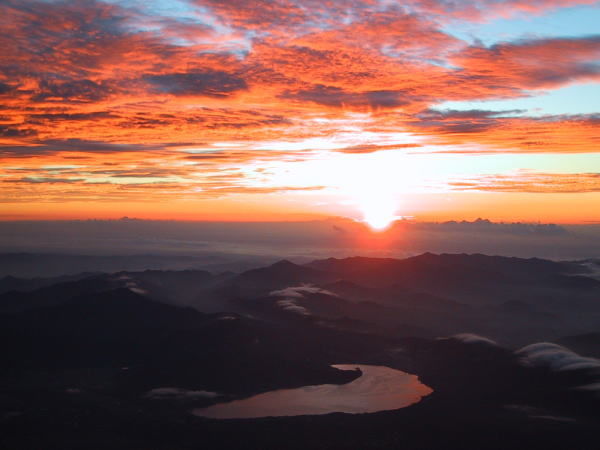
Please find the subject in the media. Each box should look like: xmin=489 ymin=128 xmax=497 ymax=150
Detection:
xmin=0 ymin=0 xmax=600 ymax=207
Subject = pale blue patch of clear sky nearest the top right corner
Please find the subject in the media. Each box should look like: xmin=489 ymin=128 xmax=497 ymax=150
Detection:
xmin=442 ymin=2 xmax=600 ymax=46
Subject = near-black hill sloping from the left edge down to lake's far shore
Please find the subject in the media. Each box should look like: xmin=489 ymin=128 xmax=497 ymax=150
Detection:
xmin=0 ymin=289 xmax=390 ymax=394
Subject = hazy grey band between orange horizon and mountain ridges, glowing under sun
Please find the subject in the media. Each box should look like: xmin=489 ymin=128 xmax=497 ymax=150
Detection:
xmin=5 ymin=218 xmax=600 ymax=278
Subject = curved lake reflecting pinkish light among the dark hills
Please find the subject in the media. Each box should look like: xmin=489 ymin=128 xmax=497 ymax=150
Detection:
xmin=193 ymin=364 xmax=433 ymax=419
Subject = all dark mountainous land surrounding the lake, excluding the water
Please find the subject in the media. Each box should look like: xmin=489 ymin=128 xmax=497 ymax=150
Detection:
xmin=0 ymin=255 xmax=600 ymax=450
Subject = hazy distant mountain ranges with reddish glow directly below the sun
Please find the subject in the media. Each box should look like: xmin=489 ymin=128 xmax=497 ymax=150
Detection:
xmin=0 ymin=253 xmax=600 ymax=345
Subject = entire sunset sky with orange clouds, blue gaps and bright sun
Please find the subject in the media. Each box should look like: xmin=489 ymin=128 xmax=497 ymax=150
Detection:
xmin=0 ymin=0 xmax=600 ymax=225
